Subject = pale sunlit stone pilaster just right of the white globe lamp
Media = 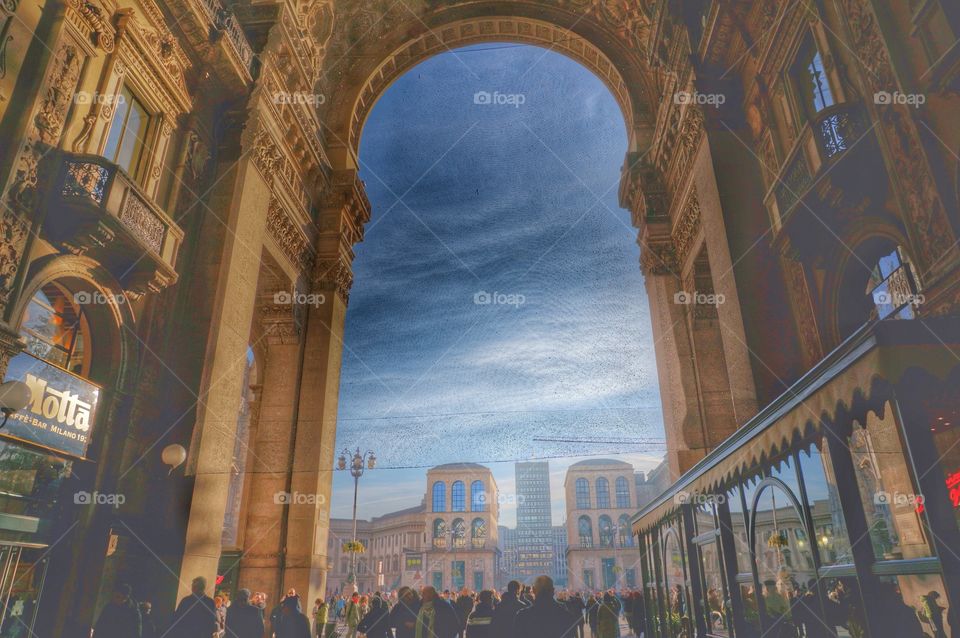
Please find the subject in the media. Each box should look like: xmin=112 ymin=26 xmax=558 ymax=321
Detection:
xmin=179 ymin=113 xmax=278 ymax=597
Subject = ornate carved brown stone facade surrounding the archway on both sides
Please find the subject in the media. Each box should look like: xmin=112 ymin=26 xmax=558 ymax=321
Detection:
xmin=0 ymin=0 xmax=960 ymax=636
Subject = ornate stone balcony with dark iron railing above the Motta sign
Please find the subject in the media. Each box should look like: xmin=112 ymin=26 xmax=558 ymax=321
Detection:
xmin=43 ymin=153 xmax=183 ymax=295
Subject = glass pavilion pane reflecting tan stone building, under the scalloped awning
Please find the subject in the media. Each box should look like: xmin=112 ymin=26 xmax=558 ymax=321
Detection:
xmin=849 ymin=403 xmax=931 ymax=560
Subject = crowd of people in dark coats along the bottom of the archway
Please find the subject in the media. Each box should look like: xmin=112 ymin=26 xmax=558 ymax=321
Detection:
xmin=93 ymin=576 xmax=645 ymax=638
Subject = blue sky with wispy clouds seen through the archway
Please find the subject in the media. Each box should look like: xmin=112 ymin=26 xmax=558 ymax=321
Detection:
xmin=331 ymin=45 xmax=663 ymax=524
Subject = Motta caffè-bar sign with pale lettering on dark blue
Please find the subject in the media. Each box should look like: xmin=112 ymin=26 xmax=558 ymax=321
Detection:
xmin=0 ymin=352 xmax=100 ymax=458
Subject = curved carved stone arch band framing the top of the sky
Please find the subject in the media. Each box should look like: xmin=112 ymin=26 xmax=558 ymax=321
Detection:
xmin=320 ymin=3 xmax=654 ymax=169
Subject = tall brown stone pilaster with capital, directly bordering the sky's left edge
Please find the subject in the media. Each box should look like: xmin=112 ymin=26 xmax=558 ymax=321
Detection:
xmin=284 ymin=170 xmax=370 ymax=601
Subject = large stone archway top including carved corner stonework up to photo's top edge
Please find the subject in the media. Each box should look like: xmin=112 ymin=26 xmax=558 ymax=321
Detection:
xmin=320 ymin=0 xmax=658 ymax=169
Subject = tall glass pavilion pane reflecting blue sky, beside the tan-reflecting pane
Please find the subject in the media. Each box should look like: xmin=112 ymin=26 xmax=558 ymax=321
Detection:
xmin=800 ymin=437 xmax=853 ymax=565
